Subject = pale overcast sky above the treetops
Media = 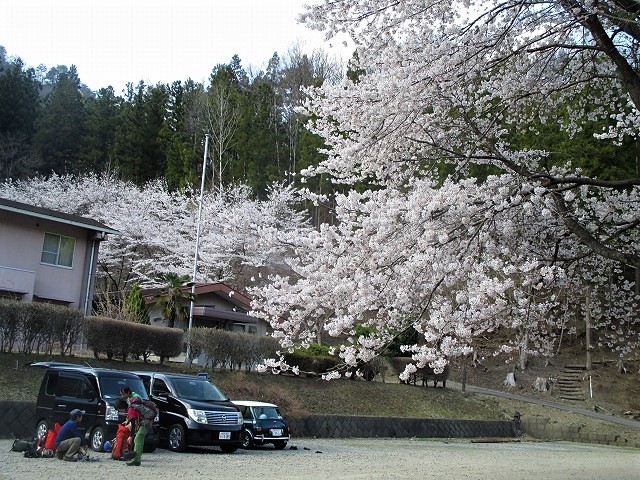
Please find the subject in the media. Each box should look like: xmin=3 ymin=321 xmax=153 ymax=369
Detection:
xmin=0 ymin=0 xmax=348 ymax=94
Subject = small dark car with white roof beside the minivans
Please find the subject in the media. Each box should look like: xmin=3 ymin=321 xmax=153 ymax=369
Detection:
xmin=233 ymin=400 xmax=291 ymax=449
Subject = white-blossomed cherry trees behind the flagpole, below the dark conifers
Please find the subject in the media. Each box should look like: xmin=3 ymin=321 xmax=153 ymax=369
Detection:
xmin=0 ymin=174 xmax=306 ymax=298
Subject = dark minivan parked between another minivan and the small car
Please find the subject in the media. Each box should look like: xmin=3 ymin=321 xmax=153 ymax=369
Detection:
xmin=135 ymin=372 xmax=242 ymax=453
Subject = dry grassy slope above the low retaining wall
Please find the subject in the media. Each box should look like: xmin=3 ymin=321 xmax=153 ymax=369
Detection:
xmin=0 ymin=354 xmax=640 ymax=442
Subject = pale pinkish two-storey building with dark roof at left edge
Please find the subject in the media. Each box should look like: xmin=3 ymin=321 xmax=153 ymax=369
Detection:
xmin=0 ymin=198 xmax=120 ymax=314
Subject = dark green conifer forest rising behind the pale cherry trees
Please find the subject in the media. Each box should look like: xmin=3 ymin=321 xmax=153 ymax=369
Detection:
xmin=0 ymin=46 xmax=343 ymax=206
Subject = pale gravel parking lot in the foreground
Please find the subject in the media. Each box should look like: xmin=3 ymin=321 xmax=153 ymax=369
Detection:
xmin=0 ymin=439 xmax=640 ymax=480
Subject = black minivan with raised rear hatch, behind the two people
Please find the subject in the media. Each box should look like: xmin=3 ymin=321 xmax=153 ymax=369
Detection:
xmin=31 ymin=362 xmax=158 ymax=452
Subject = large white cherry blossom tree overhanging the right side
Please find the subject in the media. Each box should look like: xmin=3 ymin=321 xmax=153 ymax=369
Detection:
xmin=248 ymin=0 xmax=640 ymax=378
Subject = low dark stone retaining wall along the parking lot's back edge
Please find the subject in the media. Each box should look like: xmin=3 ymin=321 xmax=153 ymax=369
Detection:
xmin=0 ymin=401 xmax=640 ymax=448
